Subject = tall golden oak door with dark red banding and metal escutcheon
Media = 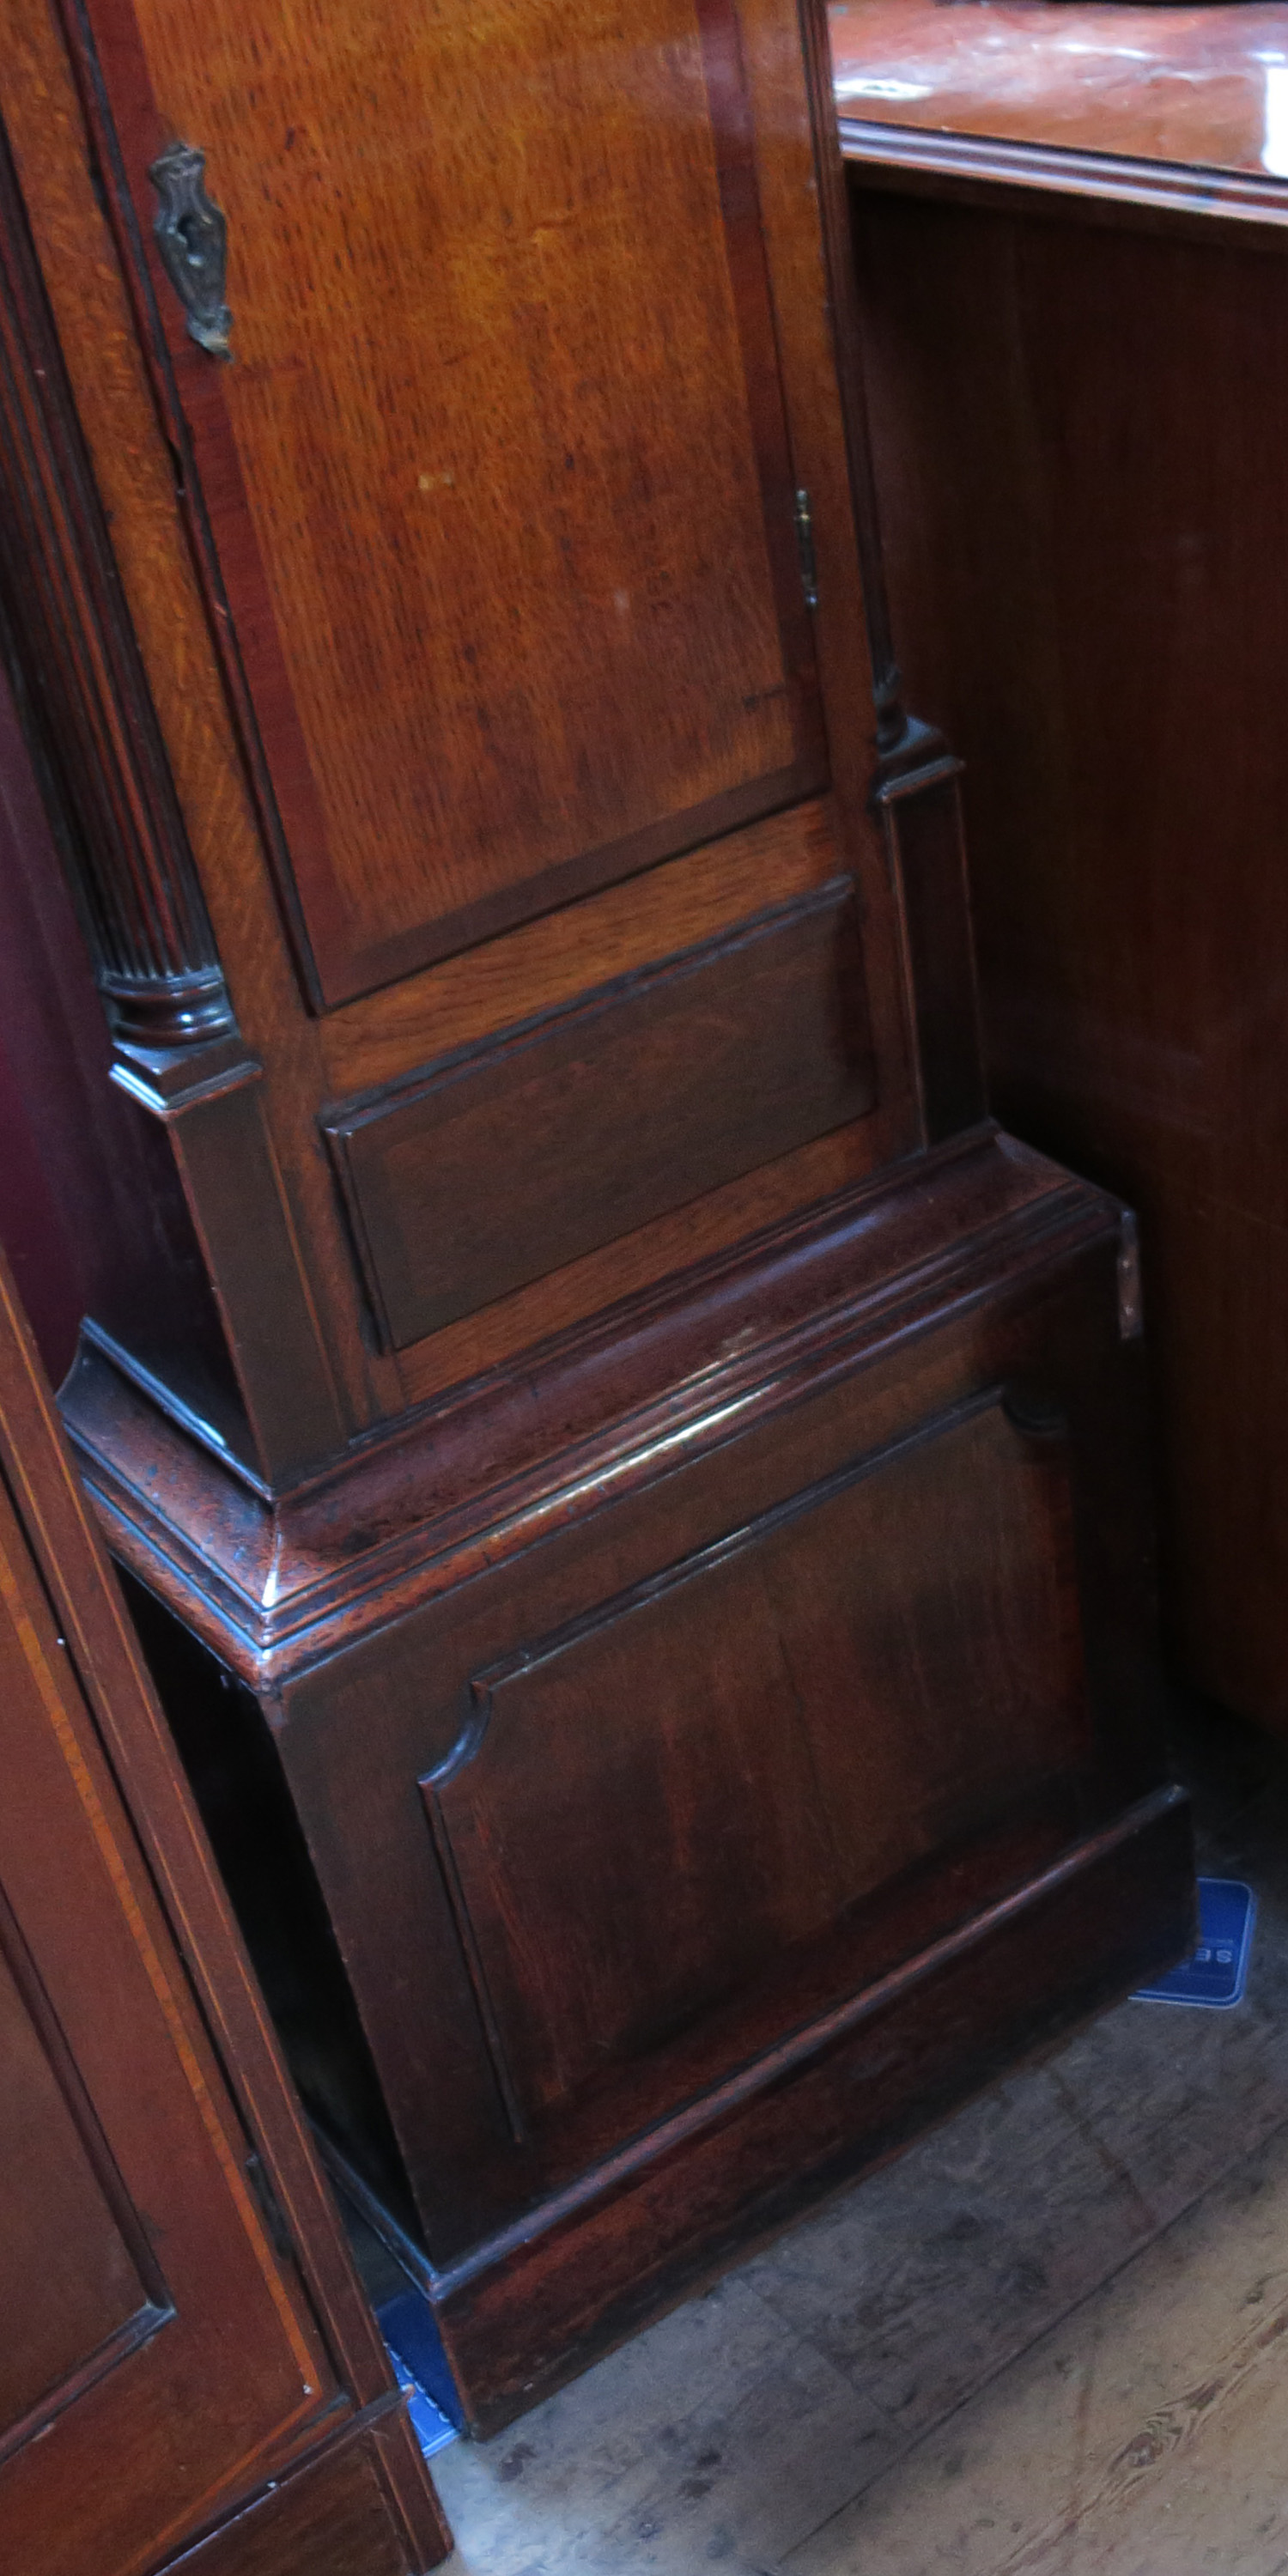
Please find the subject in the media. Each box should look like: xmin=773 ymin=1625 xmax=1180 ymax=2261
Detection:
xmin=77 ymin=0 xmax=822 ymax=999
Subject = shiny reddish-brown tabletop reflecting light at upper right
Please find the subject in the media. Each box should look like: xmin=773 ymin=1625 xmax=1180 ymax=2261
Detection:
xmin=829 ymin=0 xmax=1288 ymax=180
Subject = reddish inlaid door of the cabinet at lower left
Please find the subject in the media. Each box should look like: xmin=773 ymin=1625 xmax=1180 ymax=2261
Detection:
xmin=0 ymin=1486 xmax=332 ymax=2576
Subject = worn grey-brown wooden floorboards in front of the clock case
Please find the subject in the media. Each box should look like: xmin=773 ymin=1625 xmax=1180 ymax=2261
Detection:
xmin=435 ymin=1728 xmax=1288 ymax=2576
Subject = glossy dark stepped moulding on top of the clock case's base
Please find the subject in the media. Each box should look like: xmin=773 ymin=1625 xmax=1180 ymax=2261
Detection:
xmin=59 ymin=1131 xmax=1097 ymax=1680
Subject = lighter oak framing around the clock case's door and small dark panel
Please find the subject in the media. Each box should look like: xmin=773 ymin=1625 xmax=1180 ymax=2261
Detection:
xmin=5 ymin=0 xmax=920 ymax=1481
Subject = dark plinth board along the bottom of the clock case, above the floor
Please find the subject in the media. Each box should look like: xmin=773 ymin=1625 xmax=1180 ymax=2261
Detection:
xmin=438 ymin=1790 xmax=1193 ymax=2434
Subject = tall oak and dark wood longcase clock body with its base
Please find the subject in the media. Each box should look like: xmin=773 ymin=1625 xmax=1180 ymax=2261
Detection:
xmin=0 ymin=0 xmax=1188 ymax=2463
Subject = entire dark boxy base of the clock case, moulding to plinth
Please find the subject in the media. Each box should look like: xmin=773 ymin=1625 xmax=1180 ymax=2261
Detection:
xmin=67 ymin=1131 xmax=1188 ymax=2424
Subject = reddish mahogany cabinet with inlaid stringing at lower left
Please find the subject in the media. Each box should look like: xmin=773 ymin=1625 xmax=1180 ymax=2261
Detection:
xmin=0 ymin=1236 xmax=448 ymax=2576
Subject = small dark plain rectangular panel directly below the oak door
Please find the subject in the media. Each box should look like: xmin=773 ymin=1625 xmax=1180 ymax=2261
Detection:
xmin=325 ymin=878 xmax=876 ymax=1347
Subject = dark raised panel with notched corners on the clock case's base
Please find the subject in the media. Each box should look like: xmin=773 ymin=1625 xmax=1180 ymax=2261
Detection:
xmin=422 ymin=1404 xmax=1087 ymax=2130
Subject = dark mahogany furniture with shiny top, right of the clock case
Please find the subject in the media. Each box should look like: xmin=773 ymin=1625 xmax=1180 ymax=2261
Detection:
xmin=832 ymin=5 xmax=1288 ymax=1728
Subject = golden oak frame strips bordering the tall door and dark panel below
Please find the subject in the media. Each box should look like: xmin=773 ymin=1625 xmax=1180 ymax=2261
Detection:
xmin=5 ymin=0 xmax=938 ymax=1463
